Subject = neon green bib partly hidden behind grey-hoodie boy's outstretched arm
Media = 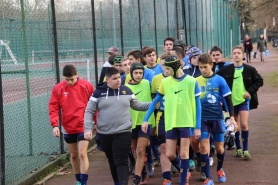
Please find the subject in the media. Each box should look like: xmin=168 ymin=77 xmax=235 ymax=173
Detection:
xmin=126 ymin=79 xmax=155 ymax=129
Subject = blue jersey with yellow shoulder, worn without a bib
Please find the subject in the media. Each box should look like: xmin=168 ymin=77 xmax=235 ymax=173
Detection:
xmin=196 ymin=74 xmax=231 ymax=120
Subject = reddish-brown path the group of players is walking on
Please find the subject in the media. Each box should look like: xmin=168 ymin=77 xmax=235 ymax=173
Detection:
xmin=46 ymin=48 xmax=278 ymax=185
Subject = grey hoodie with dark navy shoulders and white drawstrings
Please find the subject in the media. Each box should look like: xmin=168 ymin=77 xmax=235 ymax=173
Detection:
xmin=84 ymin=83 xmax=150 ymax=134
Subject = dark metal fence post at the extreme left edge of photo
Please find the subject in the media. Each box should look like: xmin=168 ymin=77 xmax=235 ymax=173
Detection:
xmin=0 ymin=58 xmax=6 ymax=184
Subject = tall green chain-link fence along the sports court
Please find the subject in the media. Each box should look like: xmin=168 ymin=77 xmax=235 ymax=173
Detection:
xmin=0 ymin=0 xmax=240 ymax=185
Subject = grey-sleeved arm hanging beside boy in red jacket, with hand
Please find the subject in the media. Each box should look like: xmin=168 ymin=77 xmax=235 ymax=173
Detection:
xmin=84 ymin=96 xmax=97 ymax=140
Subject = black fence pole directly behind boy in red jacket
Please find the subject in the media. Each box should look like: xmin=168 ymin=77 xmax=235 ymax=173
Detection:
xmin=51 ymin=0 xmax=65 ymax=154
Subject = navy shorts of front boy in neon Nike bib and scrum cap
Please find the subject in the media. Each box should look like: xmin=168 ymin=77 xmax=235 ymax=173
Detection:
xmin=166 ymin=128 xmax=194 ymax=140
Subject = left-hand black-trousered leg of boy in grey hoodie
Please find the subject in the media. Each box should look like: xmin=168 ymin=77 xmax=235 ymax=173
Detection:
xmin=99 ymin=134 xmax=119 ymax=183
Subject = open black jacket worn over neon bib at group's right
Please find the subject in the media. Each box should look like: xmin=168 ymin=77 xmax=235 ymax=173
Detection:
xmin=218 ymin=64 xmax=264 ymax=109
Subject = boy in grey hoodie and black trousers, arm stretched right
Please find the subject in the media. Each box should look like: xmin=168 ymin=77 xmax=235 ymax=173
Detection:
xmin=84 ymin=67 xmax=150 ymax=185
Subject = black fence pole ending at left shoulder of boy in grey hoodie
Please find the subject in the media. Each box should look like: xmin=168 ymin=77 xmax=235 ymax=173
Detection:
xmin=91 ymin=0 xmax=98 ymax=84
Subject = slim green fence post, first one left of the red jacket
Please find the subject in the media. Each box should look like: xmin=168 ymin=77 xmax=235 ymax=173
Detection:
xmin=20 ymin=0 xmax=33 ymax=155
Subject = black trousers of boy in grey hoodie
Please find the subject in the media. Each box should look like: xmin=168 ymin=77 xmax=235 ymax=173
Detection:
xmin=99 ymin=132 xmax=131 ymax=185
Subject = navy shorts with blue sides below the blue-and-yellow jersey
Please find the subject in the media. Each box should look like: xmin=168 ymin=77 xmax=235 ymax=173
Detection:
xmin=199 ymin=120 xmax=226 ymax=142
